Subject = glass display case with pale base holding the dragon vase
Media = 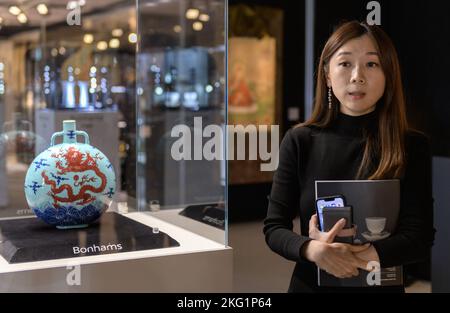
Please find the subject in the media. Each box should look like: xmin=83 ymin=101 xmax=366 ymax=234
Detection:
xmin=0 ymin=0 xmax=232 ymax=292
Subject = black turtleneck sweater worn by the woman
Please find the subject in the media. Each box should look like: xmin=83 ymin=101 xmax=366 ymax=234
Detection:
xmin=264 ymin=111 xmax=434 ymax=292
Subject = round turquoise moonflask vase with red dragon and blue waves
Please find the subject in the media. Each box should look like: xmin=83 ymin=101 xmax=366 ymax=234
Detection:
xmin=24 ymin=121 xmax=116 ymax=229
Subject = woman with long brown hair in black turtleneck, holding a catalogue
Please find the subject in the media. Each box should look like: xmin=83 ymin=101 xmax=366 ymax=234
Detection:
xmin=264 ymin=21 xmax=434 ymax=292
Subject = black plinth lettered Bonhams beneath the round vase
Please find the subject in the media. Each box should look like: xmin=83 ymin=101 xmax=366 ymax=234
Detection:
xmin=0 ymin=212 xmax=180 ymax=263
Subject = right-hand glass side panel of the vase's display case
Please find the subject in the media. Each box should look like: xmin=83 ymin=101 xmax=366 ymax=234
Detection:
xmin=137 ymin=0 xmax=227 ymax=244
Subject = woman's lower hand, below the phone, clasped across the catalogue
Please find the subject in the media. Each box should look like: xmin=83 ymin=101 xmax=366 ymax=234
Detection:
xmin=303 ymin=240 xmax=370 ymax=278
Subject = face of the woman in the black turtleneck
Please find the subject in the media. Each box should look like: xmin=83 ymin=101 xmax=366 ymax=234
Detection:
xmin=327 ymin=35 xmax=386 ymax=116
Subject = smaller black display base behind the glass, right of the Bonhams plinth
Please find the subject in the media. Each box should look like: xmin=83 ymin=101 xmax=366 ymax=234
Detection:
xmin=179 ymin=203 xmax=225 ymax=229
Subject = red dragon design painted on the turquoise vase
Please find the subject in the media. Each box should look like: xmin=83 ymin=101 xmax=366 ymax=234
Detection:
xmin=41 ymin=147 xmax=107 ymax=208
